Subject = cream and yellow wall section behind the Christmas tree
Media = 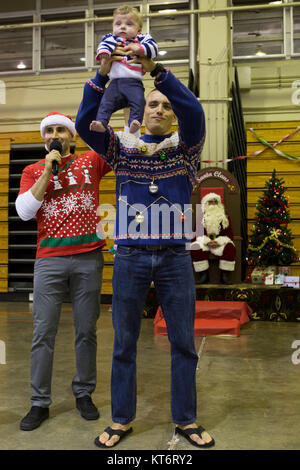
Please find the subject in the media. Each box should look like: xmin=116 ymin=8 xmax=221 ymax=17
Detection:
xmin=237 ymin=59 xmax=300 ymax=275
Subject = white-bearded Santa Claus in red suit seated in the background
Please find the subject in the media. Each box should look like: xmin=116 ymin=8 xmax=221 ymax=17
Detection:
xmin=191 ymin=193 xmax=236 ymax=284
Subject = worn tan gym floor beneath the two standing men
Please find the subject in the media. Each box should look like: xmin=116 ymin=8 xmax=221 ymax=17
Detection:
xmin=0 ymin=302 xmax=300 ymax=452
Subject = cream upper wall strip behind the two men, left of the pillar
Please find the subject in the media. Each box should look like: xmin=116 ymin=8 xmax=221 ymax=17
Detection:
xmin=0 ymin=66 xmax=188 ymax=135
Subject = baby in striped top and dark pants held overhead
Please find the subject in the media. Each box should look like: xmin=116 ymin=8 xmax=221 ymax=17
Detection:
xmin=90 ymin=5 xmax=157 ymax=133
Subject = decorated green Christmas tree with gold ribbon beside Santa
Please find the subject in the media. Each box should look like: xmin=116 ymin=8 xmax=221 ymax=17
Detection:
xmin=248 ymin=170 xmax=298 ymax=266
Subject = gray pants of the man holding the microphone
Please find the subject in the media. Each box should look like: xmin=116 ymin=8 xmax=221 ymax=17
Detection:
xmin=31 ymin=249 xmax=104 ymax=407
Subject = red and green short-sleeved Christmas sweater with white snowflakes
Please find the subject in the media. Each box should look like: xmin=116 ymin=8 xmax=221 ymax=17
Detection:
xmin=19 ymin=151 xmax=111 ymax=258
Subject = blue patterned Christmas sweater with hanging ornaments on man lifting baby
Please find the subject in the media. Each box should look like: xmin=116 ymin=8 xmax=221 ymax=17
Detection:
xmin=76 ymin=70 xmax=205 ymax=245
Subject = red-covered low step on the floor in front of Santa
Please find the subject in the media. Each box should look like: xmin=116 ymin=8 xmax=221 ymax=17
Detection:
xmin=154 ymin=300 xmax=252 ymax=336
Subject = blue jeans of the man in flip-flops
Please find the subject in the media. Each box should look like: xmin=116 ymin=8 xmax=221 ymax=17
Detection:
xmin=111 ymin=245 xmax=198 ymax=425
